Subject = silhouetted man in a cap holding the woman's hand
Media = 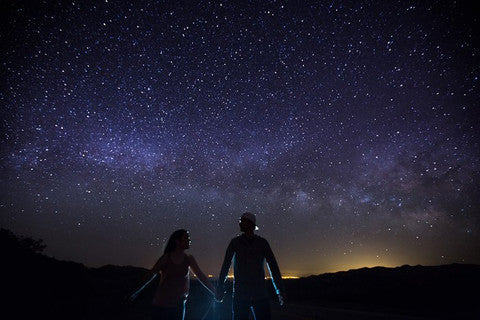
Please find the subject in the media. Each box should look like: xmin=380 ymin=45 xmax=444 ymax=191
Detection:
xmin=217 ymin=212 xmax=285 ymax=320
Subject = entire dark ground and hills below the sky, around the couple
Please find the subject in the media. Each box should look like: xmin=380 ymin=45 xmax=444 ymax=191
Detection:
xmin=0 ymin=230 xmax=480 ymax=320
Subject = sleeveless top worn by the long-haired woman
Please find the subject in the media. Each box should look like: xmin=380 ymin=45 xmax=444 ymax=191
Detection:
xmin=153 ymin=254 xmax=190 ymax=307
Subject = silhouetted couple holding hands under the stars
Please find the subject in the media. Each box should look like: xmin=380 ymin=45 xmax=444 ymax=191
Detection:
xmin=131 ymin=212 xmax=285 ymax=320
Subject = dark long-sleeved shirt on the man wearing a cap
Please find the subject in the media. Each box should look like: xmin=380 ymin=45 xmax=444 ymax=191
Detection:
xmin=219 ymin=234 xmax=284 ymax=300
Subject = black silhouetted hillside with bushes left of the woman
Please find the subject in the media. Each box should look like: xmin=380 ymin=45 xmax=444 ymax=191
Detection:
xmin=0 ymin=229 xmax=147 ymax=319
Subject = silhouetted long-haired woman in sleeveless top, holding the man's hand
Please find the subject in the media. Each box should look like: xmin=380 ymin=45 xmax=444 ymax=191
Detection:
xmin=151 ymin=229 xmax=214 ymax=320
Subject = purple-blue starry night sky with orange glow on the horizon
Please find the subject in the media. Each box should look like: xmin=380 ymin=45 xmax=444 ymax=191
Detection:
xmin=0 ymin=0 xmax=480 ymax=276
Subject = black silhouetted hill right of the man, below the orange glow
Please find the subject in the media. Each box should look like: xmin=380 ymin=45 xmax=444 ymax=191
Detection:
xmin=280 ymin=264 xmax=480 ymax=316
